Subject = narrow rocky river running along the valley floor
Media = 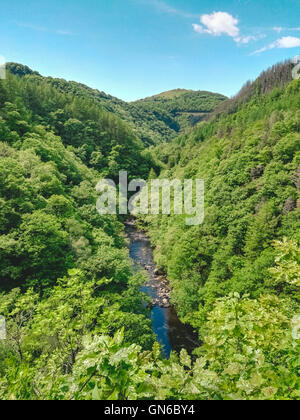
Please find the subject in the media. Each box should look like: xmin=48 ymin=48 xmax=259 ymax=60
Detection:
xmin=126 ymin=222 xmax=200 ymax=358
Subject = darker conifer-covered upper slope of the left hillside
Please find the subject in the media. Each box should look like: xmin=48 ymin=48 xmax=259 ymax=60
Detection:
xmin=1 ymin=65 xmax=157 ymax=178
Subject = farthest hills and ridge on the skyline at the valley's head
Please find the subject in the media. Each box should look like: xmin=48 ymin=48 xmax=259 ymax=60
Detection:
xmin=7 ymin=63 xmax=227 ymax=145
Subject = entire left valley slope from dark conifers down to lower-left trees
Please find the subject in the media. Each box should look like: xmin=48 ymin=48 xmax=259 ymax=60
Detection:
xmin=0 ymin=67 xmax=159 ymax=398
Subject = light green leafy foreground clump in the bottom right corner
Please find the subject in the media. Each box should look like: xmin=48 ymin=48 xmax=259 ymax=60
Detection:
xmin=199 ymin=293 xmax=300 ymax=399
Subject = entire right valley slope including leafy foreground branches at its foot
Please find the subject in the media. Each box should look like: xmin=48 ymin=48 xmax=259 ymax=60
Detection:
xmin=141 ymin=63 xmax=300 ymax=398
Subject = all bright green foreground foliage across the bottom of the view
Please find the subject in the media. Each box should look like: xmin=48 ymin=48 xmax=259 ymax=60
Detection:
xmin=0 ymin=226 xmax=300 ymax=400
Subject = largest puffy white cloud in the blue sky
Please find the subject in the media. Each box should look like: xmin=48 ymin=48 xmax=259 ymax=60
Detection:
xmin=193 ymin=12 xmax=240 ymax=38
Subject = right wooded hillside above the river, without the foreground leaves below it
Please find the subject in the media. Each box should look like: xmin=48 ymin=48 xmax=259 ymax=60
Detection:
xmin=146 ymin=62 xmax=300 ymax=325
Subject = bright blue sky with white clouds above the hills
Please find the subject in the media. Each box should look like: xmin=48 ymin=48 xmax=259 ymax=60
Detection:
xmin=0 ymin=0 xmax=300 ymax=101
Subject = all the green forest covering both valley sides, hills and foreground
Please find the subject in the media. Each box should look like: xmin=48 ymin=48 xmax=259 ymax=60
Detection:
xmin=0 ymin=63 xmax=300 ymax=400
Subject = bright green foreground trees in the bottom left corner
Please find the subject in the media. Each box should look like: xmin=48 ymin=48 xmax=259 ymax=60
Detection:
xmin=0 ymin=270 xmax=153 ymax=399
